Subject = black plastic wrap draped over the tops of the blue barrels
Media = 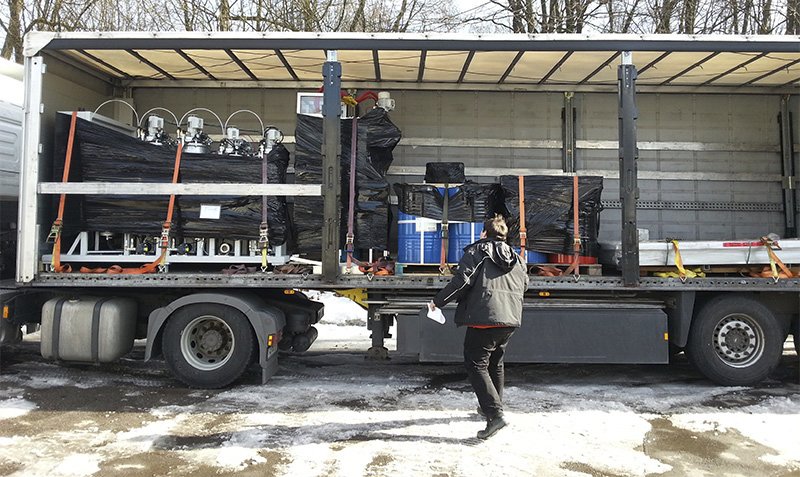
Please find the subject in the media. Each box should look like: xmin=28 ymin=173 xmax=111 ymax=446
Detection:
xmin=394 ymin=182 xmax=502 ymax=222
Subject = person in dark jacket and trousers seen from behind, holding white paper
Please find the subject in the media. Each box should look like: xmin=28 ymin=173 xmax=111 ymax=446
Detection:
xmin=429 ymin=215 xmax=528 ymax=439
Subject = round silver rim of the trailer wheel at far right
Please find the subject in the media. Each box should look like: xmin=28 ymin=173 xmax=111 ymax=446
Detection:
xmin=713 ymin=313 xmax=764 ymax=368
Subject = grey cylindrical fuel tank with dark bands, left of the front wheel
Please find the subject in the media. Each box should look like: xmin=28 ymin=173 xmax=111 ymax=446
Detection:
xmin=41 ymin=296 xmax=136 ymax=363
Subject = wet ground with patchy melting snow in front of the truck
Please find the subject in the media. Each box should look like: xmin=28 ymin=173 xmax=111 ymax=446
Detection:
xmin=0 ymin=325 xmax=800 ymax=477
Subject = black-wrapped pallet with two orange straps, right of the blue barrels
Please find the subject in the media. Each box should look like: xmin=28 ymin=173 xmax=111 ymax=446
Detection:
xmin=500 ymin=176 xmax=603 ymax=256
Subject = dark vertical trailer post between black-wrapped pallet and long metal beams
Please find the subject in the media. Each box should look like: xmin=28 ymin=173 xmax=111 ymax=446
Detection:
xmin=617 ymin=51 xmax=639 ymax=287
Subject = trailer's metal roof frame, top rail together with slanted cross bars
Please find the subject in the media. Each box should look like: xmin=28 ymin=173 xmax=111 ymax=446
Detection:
xmin=25 ymin=32 xmax=800 ymax=94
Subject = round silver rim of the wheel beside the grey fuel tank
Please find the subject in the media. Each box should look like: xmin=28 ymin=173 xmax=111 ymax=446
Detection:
xmin=181 ymin=315 xmax=236 ymax=371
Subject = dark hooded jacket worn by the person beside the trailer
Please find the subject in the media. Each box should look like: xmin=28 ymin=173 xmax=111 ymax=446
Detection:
xmin=433 ymin=239 xmax=528 ymax=327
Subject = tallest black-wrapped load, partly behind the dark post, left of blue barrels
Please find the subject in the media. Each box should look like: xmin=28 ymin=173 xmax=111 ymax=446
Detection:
xmin=294 ymin=109 xmax=400 ymax=260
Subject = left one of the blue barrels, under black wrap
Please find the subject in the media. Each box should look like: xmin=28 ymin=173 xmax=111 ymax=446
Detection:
xmin=397 ymin=212 xmax=442 ymax=263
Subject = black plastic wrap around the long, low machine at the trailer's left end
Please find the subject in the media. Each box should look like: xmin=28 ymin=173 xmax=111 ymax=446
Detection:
xmin=54 ymin=114 xmax=289 ymax=245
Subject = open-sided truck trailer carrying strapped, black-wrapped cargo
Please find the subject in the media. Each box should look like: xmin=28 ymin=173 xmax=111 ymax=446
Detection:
xmin=0 ymin=32 xmax=800 ymax=387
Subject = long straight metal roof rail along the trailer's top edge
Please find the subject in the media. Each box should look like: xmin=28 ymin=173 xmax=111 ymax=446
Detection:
xmin=25 ymin=32 xmax=800 ymax=56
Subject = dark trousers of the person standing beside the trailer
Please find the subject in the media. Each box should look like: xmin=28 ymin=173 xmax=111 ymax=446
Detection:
xmin=464 ymin=328 xmax=516 ymax=419
